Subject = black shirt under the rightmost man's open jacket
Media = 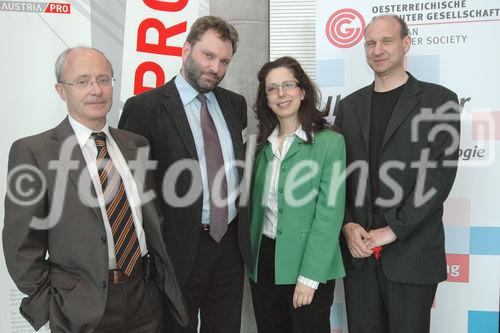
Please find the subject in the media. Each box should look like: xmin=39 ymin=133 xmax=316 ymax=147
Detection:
xmin=368 ymin=84 xmax=405 ymax=217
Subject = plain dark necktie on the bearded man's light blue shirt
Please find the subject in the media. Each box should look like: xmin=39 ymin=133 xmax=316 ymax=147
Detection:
xmin=197 ymin=94 xmax=228 ymax=242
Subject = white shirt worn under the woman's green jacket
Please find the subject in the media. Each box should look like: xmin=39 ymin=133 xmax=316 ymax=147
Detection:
xmin=262 ymin=126 xmax=319 ymax=289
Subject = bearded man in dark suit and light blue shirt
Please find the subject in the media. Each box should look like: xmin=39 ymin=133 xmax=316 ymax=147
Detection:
xmin=119 ymin=16 xmax=252 ymax=333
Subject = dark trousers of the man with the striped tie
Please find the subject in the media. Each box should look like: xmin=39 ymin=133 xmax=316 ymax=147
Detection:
xmin=94 ymin=260 xmax=165 ymax=333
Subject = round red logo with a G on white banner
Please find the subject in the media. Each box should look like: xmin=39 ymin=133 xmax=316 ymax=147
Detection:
xmin=325 ymin=8 xmax=365 ymax=49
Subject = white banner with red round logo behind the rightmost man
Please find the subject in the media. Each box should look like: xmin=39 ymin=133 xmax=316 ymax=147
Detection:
xmin=316 ymin=0 xmax=500 ymax=333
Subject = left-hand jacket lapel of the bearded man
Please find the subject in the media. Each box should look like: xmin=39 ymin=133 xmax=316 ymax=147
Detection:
xmin=162 ymin=77 xmax=198 ymax=160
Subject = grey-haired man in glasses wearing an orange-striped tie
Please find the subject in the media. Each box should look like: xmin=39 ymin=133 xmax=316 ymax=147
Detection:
xmin=2 ymin=47 xmax=187 ymax=333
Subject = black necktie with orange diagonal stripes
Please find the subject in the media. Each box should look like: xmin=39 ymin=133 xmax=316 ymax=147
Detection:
xmin=92 ymin=132 xmax=141 ymax=276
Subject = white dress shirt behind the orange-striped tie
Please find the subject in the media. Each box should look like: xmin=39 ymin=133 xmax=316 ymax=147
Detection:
xmin=68 ymin=116 xmax=148 ymax=269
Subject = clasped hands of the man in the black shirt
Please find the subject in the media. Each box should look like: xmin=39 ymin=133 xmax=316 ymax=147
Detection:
xmin=342 ymin=222 xmax=397 ymax=258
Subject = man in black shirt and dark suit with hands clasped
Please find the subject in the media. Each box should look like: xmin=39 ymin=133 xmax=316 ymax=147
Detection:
xmin=335 ymin=16 xmax=460 ymax=333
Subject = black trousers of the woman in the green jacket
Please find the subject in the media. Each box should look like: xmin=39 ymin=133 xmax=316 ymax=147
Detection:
xmin=250 ymin=236 xmax=335 ymax=333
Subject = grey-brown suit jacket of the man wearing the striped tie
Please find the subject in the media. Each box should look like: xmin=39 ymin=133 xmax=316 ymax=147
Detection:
xmin=2 ymin=118 xmax=187 ymax=332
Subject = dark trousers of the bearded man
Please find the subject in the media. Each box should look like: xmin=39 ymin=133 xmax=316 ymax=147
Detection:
xmin=166 ymin=219 xmax=244 ymax=333
